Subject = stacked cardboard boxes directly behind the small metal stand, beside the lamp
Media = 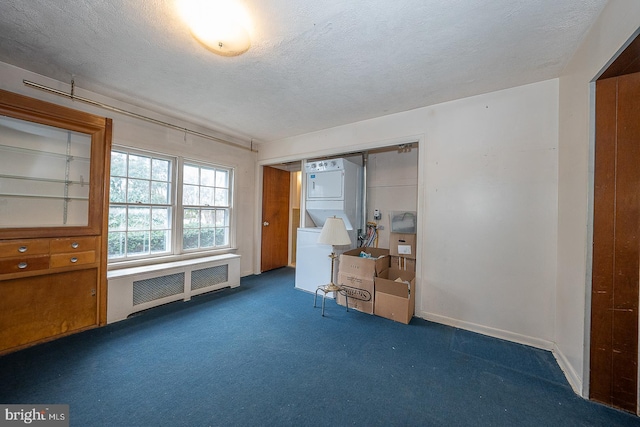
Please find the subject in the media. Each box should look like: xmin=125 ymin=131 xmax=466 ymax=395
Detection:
xmin=337 ymin=248 xmax=389 ymax=314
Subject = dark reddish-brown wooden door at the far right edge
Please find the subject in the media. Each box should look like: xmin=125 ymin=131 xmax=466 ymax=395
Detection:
xmin=589 ymin=73 xmax=640 ymax=413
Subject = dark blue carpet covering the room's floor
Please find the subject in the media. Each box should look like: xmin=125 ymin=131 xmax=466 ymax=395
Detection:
xmin=0 ymin=268 xmax=640 ymax=427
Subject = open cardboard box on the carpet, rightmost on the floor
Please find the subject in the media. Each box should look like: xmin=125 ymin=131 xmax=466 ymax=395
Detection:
xmin=374 ymin=268 xmax=416 ymax=325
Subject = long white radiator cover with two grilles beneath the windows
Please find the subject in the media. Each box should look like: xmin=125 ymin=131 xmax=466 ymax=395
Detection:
xmin=107 ymin=254 xmax=240 ymax=323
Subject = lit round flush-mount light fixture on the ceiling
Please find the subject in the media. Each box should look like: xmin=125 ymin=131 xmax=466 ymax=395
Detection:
xmin=177 ymin=0 xmax=251 ymax=56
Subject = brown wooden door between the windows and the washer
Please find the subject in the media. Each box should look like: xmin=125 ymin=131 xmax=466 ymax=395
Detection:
xmin=260 ymin=166 xmax=290 ymax=271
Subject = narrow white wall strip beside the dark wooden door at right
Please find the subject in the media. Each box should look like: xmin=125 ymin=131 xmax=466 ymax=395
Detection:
xmin=556 ymin=0 xmax=640 ymax=396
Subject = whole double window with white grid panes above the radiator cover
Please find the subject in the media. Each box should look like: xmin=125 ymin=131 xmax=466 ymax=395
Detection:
xmin=108 ymin=148 xmax=233 ymax=261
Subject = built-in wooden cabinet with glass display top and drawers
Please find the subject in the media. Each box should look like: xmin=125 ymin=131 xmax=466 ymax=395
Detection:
xmin=0 ymin=90 xmax=111 ymax=354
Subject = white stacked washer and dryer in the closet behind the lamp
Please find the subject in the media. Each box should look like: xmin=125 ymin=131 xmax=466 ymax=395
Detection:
xmin=295 ymin=158 xmax=363 ymax=292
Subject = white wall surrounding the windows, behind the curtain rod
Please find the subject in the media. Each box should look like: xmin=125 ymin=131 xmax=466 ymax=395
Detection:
xmin=0 ymin=62 xmax=257 ymax=275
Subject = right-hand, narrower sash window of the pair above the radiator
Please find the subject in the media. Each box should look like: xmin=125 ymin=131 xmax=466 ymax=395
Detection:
xmin=182 ymin=163 xmax=231 ymax=250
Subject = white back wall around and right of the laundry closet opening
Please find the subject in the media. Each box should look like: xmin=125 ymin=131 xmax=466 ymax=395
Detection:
xmin=259 ymin=80 xmax=558 ymax=348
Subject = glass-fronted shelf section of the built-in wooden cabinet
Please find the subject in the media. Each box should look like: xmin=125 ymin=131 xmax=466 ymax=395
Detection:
xmin=0 ymin=116 xmax=91 ymax=228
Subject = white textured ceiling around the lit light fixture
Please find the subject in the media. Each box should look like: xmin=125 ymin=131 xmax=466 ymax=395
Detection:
xmin=0 ymin=0 xmax=606 ymax=142
